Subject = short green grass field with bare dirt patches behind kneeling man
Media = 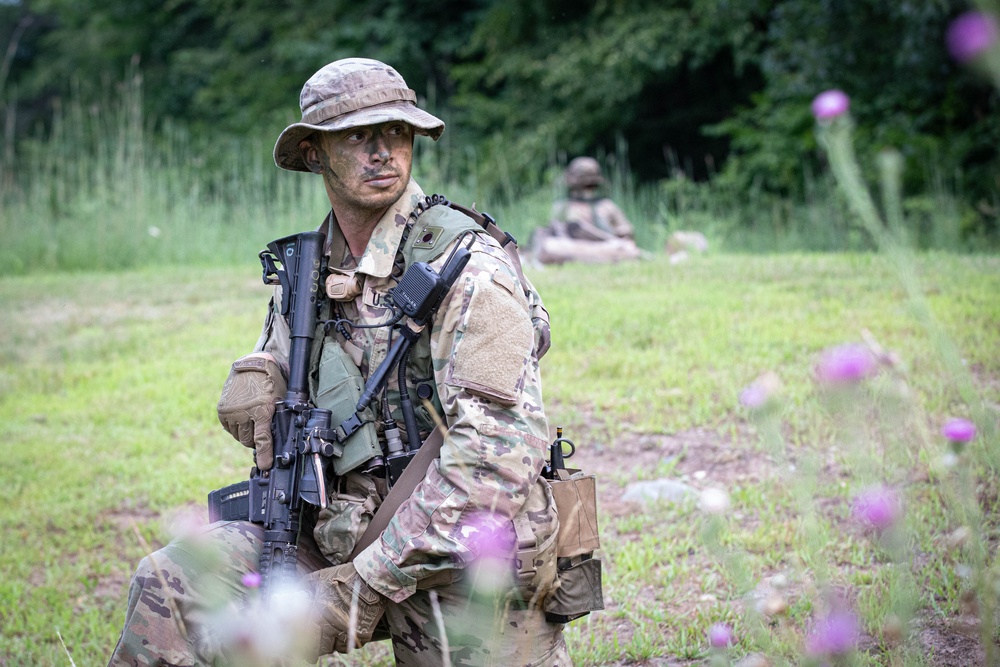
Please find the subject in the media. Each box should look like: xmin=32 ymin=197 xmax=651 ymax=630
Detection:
xmin=0 ymin=252 xmax=1000 ymax=666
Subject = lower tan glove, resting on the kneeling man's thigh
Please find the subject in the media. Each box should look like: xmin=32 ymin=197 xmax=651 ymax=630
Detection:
xmin=306 ymin=563 xmax=385 ymax=661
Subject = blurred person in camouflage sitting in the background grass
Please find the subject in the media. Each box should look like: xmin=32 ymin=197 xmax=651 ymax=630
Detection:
xmin=532 ymin=157 xmax=640 ymax=264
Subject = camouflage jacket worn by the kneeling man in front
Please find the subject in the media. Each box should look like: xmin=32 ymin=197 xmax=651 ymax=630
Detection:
xmin=256 ymin=181 xmax=557 ymax=602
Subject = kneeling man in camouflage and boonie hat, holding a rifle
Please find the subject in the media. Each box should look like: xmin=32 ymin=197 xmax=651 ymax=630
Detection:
xmin=110 ymin=58 xmax=571 ymax=666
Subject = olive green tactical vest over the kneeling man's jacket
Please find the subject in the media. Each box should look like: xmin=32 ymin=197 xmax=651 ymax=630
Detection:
xmin=310 ymin=195 xmax=528 ymax=476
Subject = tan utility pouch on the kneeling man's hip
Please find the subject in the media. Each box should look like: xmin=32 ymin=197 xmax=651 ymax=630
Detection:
xmin=545 ymin=469 xmax=604 ymax=623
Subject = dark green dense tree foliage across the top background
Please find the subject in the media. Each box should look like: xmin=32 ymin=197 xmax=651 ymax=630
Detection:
xmin=0 ymin=0 xmax=1000 ymax=229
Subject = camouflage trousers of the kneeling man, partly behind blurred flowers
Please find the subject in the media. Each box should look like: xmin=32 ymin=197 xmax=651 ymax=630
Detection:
xmin=109 ymin=522 xmax=572 ymax=667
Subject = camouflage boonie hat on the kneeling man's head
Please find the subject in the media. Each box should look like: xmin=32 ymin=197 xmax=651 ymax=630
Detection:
xmin=274 ymin=58 xmax=444 ymax=171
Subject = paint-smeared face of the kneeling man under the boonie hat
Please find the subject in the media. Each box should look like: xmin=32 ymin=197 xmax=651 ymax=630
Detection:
xmin=311 ymin=121 xmax=413 ymax=211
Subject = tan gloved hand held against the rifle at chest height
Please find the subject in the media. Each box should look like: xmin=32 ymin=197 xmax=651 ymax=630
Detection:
xmin=218 ymin=352 xmax=287 ymax=470
